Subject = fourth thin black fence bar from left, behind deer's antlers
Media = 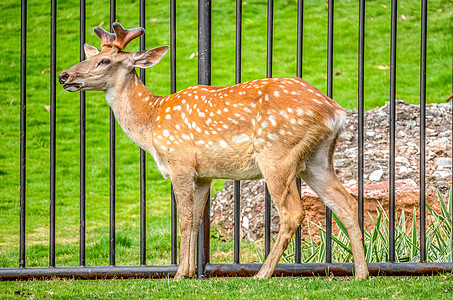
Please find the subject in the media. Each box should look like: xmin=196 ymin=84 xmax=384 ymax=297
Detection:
xmin=110 ymin=0 xmax=116 ymax=266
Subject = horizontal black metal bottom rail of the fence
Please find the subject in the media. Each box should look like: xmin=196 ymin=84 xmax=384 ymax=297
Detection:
xmin=0 ymin=262 xmax=453 ymax=281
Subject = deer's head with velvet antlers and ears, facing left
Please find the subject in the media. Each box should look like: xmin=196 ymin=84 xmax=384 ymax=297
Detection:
xmin=58 ymin=22 xmax=168 ymax=92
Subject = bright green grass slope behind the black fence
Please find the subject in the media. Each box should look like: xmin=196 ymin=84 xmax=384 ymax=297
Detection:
xmin=0 ymin=0 xmax=453 ymax=267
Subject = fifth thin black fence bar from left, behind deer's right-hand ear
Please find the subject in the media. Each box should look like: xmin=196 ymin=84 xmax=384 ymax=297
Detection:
xmin=140 ymin=0 xmax=146 ymax=266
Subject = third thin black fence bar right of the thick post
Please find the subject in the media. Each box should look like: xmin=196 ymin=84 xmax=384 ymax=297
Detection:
xmin=294 ymin=0 xmax=304 ymax=263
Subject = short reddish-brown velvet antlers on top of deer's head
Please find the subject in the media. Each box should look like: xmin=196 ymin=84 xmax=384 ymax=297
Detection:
xmin=94 ymin=22 xmax=145 ymax=50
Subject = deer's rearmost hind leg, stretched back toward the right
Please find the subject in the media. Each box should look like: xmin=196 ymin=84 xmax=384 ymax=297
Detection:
xmin=301 ymin=140 xmax=368 ymax=279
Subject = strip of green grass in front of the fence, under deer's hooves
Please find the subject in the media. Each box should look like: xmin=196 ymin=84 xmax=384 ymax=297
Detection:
xmin=0 ymin=274 xmax=453 ymax=299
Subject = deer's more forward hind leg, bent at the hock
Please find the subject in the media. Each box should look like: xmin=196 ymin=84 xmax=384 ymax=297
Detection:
xmin=255 ymin=166 xmax=305 ymax=279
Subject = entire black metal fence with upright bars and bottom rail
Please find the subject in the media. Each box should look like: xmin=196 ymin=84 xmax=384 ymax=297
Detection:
xmin=0 ymin=0 xmax=453 ymax=280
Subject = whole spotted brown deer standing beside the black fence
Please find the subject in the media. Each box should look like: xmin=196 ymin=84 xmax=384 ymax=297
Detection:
xmin=59 ymin=23 xmax=368 ymax=279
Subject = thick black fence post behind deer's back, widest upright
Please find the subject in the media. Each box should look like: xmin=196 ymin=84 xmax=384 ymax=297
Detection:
xmin=197 ymin=0 xmax=211 ymax=278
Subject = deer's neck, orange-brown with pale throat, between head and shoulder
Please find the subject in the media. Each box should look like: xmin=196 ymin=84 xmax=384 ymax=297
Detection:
xmin=105 ymin=70 xmax=162 ymax=150
